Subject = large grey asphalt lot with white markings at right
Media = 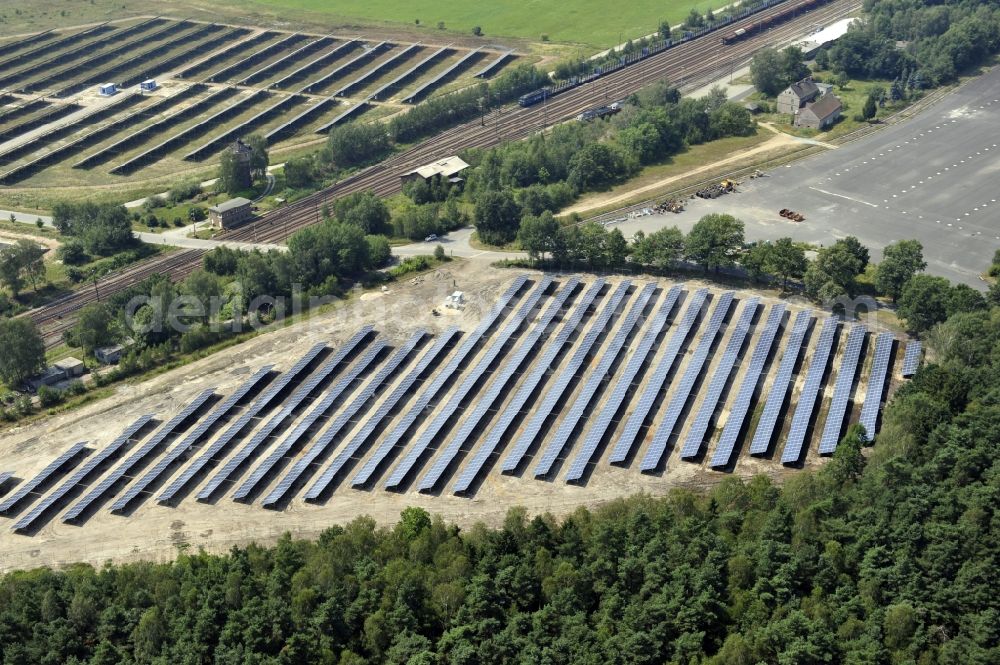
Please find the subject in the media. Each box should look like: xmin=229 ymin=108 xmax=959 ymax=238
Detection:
xmin=619 ymin=69 xmax=1000 ymax=289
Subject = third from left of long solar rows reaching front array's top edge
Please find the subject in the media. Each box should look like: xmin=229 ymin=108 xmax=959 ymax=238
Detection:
xmin=417 ymin=277 xmax=580 ymax=491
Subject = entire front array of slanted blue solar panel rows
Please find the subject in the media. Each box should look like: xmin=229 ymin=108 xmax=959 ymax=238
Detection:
xmin=0 ymin=275 xmax=922 ymax=534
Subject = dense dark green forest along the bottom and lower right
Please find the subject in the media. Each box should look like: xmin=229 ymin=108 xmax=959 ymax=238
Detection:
xmin=0 ymin=298 xmax=1000 ymax=665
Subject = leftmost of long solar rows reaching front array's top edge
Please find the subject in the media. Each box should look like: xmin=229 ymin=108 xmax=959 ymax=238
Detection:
xmin=351 ymin=275 xmax=528 ymax=487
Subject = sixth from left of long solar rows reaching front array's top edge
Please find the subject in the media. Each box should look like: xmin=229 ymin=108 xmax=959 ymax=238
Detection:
xmin=535 ymin=284 xmax=656 ymax=478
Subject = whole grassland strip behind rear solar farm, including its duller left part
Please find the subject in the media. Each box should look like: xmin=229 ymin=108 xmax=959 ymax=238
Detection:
xmin=0 ymin=0 xmax=728 ymax=48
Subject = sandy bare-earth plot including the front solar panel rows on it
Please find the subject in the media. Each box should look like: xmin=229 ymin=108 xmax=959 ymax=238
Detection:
xmin=0 ymin=261 xmax=916 ymax=568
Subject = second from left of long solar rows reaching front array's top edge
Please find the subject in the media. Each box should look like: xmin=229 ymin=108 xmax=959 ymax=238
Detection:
xmin=385 ymin=275 xmax=552 ymax=488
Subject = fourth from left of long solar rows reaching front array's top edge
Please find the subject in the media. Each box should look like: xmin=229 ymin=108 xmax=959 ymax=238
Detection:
xmin=452 ymin=279 xmax=607 ymax=494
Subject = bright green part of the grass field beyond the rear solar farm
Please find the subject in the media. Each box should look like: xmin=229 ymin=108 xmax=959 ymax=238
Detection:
xmin=242 ymin=0 xmax=722 ymax=47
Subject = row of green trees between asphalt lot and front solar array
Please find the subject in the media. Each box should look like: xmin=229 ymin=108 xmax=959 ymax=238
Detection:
xmin=516 ymin=209 xmax=1000 ymax=333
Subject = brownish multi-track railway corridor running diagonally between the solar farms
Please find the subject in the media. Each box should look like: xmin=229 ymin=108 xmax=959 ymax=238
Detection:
xmin=26 ymin=0 xmax=861 ymax=348
